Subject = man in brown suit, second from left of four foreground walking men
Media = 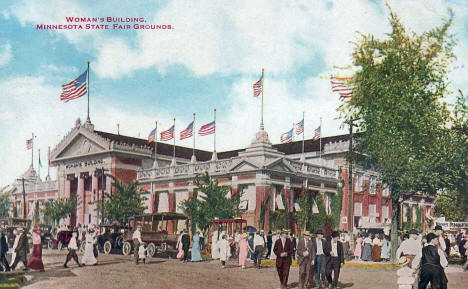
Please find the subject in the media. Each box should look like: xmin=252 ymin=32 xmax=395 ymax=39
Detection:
xmin=297 ymin=231 xmax=315 ymax=289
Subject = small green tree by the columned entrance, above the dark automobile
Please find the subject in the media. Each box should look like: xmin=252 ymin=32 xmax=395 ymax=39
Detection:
xmin=98 ymin=178 xmax=145 ymax=223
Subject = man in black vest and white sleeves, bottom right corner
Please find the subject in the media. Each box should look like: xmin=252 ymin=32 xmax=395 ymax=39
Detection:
xmin=415 ymin=233 xmax=448 ymax=289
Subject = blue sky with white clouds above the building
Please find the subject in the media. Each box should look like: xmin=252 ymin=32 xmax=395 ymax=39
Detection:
xmin=0 ymin=0 xmax=468 ymax=187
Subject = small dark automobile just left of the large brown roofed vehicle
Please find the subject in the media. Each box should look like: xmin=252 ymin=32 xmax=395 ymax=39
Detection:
xmin=97 ymin=224 xmax=129 ymax=255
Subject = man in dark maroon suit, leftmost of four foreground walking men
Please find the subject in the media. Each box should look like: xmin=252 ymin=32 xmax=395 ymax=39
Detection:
xmin=273 ymin=230 xmax=293 ymax=289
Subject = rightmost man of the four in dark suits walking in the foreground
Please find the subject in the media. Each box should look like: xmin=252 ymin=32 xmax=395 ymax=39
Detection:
xmin=323 ymin=232 xmax=344 ymax=288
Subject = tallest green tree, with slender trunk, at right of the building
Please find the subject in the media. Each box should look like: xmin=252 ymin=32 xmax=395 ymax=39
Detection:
xmin=340 ymin=4 xmax=454 ymax=257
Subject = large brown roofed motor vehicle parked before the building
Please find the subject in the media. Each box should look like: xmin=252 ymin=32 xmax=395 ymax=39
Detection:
xmin=122 ymin=213 xmax=188 ymax=256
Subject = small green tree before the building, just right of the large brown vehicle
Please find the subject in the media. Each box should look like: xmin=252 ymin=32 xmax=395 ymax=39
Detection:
xmin=179 ymin=173 xmax=239 ymax=231
